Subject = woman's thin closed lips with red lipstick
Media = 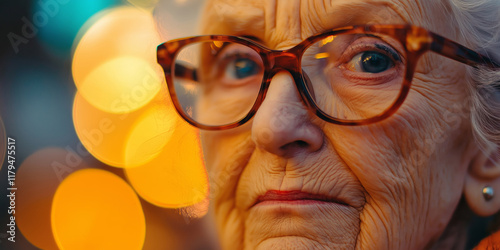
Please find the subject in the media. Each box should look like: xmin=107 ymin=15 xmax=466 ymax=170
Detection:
xmin=253 ymin=190 xmax=348 ymax=206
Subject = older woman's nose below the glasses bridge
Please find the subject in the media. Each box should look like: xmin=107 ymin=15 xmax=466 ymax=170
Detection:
xmin=252 ymin=71 xmax=324 ymax=158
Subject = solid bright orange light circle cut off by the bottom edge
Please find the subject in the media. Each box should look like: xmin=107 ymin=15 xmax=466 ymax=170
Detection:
xmin=51 ymin=169 xmax=146 ymax=249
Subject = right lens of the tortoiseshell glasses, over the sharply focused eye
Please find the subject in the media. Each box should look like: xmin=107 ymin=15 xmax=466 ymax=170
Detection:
xmin=301 ymin=34 xmax=406 ymax=121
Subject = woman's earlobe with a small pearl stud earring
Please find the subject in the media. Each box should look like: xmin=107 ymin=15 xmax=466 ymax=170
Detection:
xmin=464 ymin=148 xmax=500 ymax=216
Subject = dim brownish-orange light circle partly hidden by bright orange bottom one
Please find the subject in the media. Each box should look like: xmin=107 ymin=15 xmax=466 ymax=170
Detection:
xmin=16 ymin=148 xmax=93 ymax=249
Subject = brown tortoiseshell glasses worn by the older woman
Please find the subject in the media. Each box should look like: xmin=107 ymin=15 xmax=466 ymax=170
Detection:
xmin=157 ymin=25 xmax=499 ymax=130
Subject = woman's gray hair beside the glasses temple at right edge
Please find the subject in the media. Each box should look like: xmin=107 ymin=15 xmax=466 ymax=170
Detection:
xmin=449 ymin=0 xmax=500 ymax=152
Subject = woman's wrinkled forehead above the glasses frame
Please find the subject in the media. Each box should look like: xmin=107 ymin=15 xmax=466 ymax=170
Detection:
xmin=202 ymin=0 xmax=445 ymax=46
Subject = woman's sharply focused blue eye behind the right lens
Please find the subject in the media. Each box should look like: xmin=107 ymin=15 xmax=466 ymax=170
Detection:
xmin=346 ymin=51 xmax=394 ymax=73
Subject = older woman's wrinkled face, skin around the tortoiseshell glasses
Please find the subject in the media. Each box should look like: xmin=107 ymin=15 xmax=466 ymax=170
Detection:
xmin=200 ymin=0 xmax=475 ymax=249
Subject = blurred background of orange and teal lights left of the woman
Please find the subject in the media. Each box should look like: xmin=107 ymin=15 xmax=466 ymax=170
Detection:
xmin=0 ymin=0 xmax=216 ymax=249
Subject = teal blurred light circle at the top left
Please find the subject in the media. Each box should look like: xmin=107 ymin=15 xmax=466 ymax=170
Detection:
xmin=31 ymin=0 xmax=122 ymax=57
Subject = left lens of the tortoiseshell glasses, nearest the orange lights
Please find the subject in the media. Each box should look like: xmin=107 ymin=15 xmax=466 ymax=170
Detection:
xmin=173 ymin=41 xmax=264 ymax=126
